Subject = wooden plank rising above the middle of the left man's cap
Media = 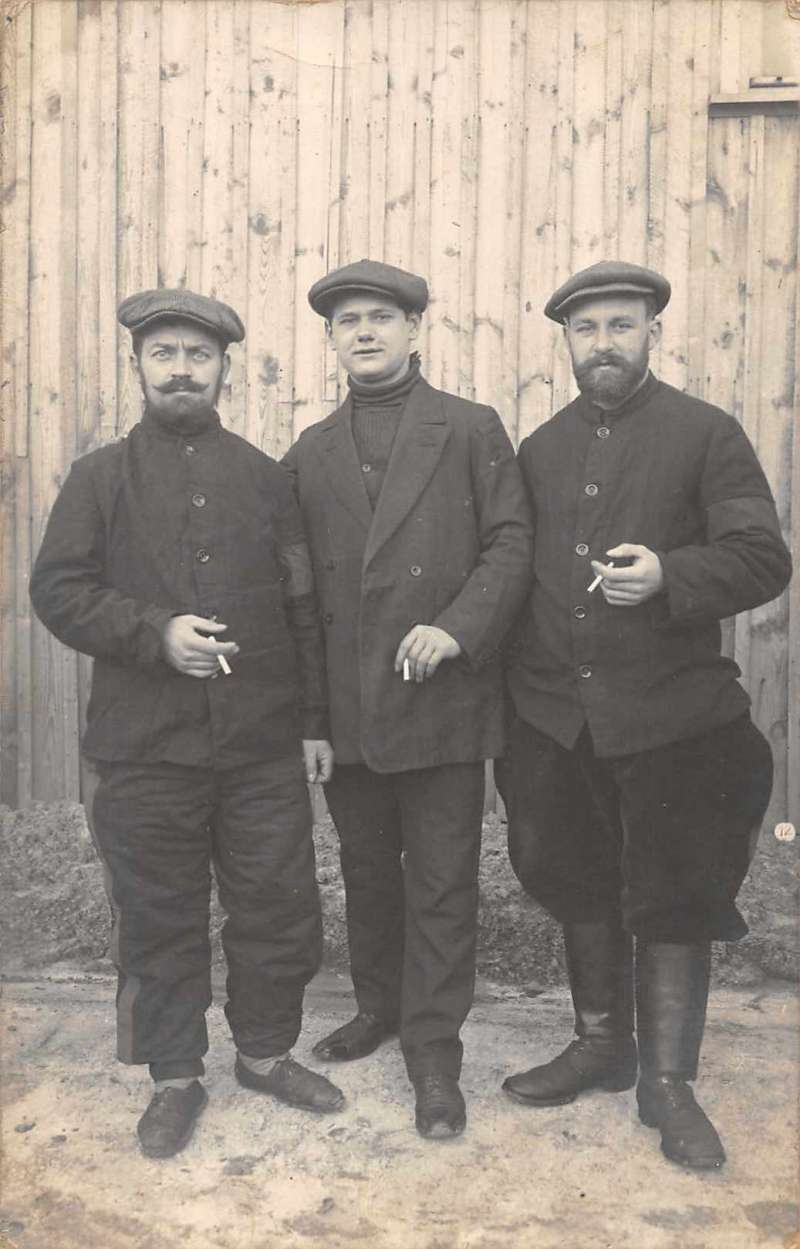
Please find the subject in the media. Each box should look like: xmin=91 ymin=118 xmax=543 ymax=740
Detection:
xmin=159 ymin=0 xmax=206 ymax=290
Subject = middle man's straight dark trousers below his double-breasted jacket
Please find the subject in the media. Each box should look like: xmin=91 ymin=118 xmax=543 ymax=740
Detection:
xmin=326 ymin=763 xmax=484 ymax=1077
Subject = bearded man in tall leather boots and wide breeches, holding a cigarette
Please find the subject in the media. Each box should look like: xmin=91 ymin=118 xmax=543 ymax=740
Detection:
xmin=503 ymin=261 xmax=791 ymax=1168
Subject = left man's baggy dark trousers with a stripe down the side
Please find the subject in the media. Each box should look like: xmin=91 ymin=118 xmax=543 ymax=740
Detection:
xmin=92 ymin=756 xmax=322 ymax=1079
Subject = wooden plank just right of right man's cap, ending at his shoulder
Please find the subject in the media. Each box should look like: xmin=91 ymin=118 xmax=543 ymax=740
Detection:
xmin=659 ymin=0 xmax=698 ymax=390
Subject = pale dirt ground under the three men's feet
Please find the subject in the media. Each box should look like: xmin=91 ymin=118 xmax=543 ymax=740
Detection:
xmin=0 ymin=967 xmax=800 ymax=1249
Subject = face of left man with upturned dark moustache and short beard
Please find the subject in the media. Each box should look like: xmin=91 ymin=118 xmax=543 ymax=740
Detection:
xmin=132 ymin=321 xmax=231 ymax=425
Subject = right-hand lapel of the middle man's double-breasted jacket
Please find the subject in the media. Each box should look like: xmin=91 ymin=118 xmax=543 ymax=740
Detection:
xmin=362 ymin=380 xmax=451 ymax=567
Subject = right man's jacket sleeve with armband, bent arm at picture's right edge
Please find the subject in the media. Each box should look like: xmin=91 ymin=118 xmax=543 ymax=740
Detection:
xmin=659 ymin=416 xmax=791 ymax=625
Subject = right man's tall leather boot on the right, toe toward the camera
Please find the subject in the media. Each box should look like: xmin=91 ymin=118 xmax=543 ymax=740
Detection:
xmin=637 ymin=940 xmax=725 ymax=1170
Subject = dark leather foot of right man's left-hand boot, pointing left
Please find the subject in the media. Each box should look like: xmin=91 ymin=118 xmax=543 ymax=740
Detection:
xmin=503 ymin=1037 xmax=637 ymax=1105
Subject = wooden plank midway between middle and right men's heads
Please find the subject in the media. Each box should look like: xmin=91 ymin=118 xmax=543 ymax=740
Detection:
xmin=474 ymin=2 xmax=513 ymax=410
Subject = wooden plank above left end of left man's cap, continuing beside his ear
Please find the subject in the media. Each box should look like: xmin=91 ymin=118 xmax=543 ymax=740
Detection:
xmin=116 ymin=0 xmax=161 ymax=433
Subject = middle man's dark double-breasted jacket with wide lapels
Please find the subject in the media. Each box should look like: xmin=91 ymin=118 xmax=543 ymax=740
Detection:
xmin=283 ymin=378 xmax=532 ymax=772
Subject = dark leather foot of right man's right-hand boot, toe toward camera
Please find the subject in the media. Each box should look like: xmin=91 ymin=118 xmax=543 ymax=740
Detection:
xmin=637 ymin=1075 xmax=725 ymax=1170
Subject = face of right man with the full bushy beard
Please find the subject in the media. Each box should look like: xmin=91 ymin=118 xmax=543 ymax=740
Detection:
xmin=564 ymin=295 xmax=661 ymax=408
